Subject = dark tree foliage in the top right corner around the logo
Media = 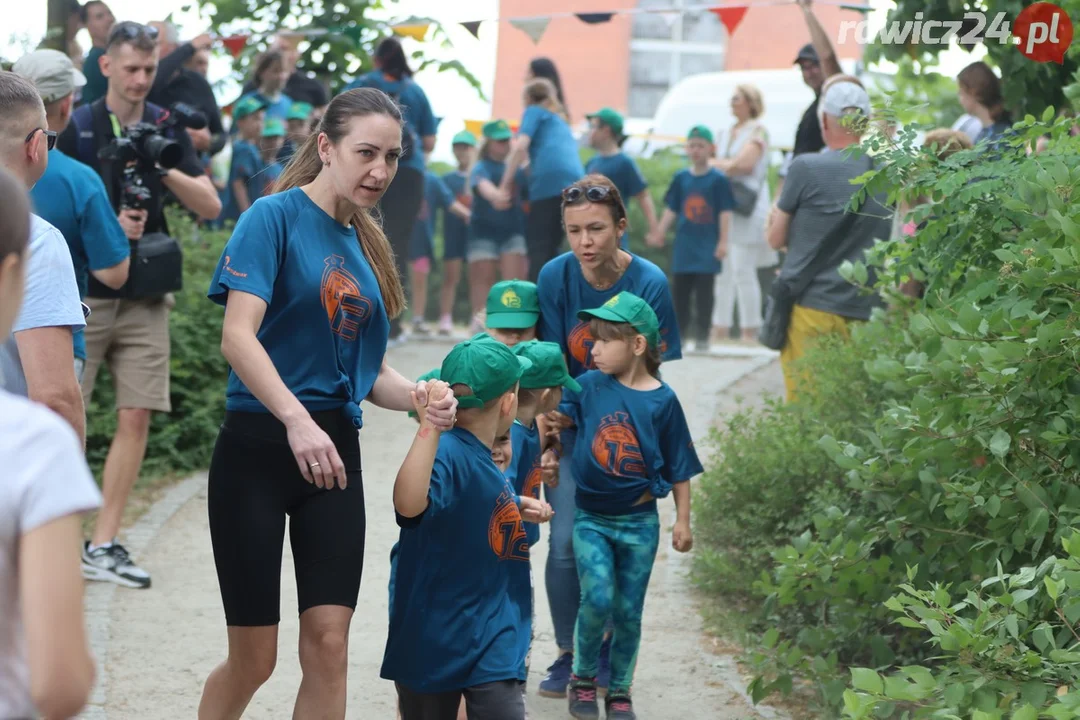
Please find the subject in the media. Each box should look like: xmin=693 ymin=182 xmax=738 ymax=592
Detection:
xmin=868 ymin=0 xmax=1080 ymax=117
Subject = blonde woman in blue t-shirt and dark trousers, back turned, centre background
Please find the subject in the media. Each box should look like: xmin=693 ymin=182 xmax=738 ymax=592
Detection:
xmin=499 ymin=78 xmax=585 ymax=282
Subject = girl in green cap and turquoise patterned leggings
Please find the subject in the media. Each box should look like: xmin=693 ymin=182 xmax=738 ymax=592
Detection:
xmin=548 ymin=293 xmax=702 ymax=719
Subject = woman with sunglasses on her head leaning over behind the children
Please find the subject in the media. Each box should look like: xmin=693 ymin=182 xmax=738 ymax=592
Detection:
xmin=537 ymin=175 xmax=683 ymax=697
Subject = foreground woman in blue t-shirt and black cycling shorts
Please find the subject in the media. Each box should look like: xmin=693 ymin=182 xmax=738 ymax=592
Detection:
xmin=199 ymin=89 xmax=457 ymax=718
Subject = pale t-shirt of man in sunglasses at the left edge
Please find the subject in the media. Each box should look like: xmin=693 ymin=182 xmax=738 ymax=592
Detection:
xmin=0 ymin=215 xmax=86 ymax=397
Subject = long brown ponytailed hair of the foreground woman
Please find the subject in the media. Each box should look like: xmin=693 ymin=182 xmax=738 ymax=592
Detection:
xmin=272 ymin=87 xmax=405 ymax=318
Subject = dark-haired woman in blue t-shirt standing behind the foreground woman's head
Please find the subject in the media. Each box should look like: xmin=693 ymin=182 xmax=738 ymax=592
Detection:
xmin=346 ymin=38 xmax=436 ymax=339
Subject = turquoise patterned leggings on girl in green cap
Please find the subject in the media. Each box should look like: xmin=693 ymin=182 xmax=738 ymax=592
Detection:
xmin=573 ymin=510 xmax=660 ymax=691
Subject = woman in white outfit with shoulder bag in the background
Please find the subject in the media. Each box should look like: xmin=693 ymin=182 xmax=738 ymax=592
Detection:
xmin=711 ymin=85 xmax=779 ymax=342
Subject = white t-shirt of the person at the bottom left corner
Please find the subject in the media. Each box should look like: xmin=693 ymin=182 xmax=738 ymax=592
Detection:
xmin=0 ymin=390 xmax=102 ymax=718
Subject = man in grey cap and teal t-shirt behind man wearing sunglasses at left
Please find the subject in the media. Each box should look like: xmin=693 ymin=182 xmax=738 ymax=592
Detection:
xmin=12 ymin=50 xmax=131 ymax=382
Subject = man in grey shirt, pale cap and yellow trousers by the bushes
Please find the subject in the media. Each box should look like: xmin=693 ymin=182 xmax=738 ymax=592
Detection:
xmin=767 ymin=74 xmax=892 ymax=400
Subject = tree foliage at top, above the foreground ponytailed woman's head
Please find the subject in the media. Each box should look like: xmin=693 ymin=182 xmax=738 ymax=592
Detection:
xmin=189 ymin=0 xmax=480 ymax=99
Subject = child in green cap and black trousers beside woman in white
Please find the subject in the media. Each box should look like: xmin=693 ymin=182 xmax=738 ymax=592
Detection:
xmin=649 ymin=125 xmax=735 ymax=351
